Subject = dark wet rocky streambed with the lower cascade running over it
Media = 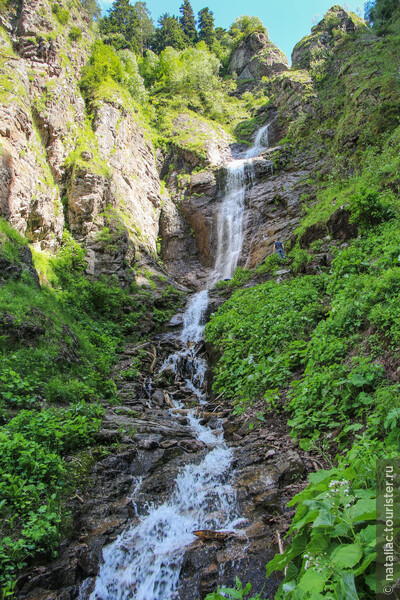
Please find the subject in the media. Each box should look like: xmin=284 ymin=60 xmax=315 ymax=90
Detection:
xmin=17 ymin=298 xmax=320 ymax=600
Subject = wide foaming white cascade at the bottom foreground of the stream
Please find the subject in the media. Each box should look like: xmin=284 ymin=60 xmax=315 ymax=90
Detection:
xmin=91 ymin=446 xmax=235 ymax=600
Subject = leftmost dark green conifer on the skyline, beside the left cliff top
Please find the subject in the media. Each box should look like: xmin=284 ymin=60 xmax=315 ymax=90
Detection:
xmin=100 ymin=0 xmax=140 ymax=52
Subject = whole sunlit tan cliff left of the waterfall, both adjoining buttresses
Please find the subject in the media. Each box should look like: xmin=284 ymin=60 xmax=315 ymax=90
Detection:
xmin=0 ymin=0 xmax=161 ymax=280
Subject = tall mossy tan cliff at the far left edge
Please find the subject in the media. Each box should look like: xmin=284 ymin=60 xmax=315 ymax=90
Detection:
xmin=0 ymin=0 xmax=91 ymax=249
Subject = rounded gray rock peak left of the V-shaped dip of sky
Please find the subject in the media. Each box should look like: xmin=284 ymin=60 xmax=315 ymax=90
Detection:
xmin=230 ymin=32 xmax=289 ymax=79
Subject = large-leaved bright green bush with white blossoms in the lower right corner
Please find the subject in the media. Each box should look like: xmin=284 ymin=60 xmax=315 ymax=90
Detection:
xmin=267 ymin=439 xmax=384 ymax=600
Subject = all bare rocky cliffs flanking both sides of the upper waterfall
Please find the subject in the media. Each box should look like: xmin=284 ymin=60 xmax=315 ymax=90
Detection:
xmin=0 ymin=0 xmax=364 ymax=288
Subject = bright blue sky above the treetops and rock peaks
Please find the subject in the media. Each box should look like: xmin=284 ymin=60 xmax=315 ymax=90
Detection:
xmin=99 ymin=0 xmax=364 ymax=58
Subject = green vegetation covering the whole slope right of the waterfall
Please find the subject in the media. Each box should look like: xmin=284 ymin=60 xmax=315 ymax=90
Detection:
xmin=206 ymin=9 xmax=400 ymax=600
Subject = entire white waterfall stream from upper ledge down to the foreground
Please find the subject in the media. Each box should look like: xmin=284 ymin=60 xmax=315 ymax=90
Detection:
xmin=90 ymin=125 xmax=268 ymax=600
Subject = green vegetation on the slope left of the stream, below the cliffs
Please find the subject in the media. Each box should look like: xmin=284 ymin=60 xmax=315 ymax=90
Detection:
xmin=0 ymin=226 xmax=179 ymax=598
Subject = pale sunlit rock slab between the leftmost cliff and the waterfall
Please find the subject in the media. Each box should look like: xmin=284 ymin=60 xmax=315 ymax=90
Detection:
xmin=68 ymin=103 xmax=161 ymax=280
